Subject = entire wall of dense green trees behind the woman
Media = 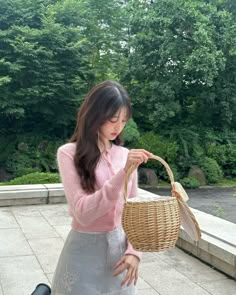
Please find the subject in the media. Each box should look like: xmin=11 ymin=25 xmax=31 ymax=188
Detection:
xmin=0 ymin=0 xmax=236 ymax=180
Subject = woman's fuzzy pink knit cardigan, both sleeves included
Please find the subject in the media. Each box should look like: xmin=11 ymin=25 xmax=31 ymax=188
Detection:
xmin=57 ymin=143 xmax=141 ymax=259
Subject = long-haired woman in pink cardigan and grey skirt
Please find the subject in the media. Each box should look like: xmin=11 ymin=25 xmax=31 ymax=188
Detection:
xmin=52 ymin=81 xmax=152 ymax=295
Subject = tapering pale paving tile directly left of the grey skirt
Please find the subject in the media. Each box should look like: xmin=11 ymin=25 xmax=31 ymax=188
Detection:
xmin=29 ymin=238 xmax=64 ymax=273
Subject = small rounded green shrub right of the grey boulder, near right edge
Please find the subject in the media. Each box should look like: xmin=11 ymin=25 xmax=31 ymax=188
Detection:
xmin=200 ymin=157 xmax=223 ymax=184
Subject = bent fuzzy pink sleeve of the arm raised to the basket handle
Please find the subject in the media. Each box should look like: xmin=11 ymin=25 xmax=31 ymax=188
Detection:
xmin=57 ymin=148 xmax=125 ymax=226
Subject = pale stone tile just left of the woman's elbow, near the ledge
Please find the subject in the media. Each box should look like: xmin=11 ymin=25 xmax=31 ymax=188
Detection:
xmin=40 ymin=205 xmax=71 ymax=225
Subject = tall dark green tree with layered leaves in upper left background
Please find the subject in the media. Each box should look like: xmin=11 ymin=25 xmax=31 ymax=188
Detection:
xmin=0 ymin=0 xmax=93 ymax=134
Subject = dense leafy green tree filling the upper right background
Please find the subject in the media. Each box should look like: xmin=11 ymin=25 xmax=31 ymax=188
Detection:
xmin=127 ymin=0 xmax=236 ymax=131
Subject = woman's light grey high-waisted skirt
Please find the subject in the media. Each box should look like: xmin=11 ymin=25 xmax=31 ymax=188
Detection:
xmin=51 ymin=226 xmax=137 ymax=295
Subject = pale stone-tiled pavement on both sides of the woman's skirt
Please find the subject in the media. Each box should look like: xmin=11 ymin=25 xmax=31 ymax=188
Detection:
xmin=0 ymin=204 xmax=236 ymax=295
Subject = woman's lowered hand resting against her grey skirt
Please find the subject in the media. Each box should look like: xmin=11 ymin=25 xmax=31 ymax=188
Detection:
xmin=113 ymin=255 xmax=140 ymax=286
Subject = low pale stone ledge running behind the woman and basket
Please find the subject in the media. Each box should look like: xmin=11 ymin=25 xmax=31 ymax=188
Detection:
xmin=0 ymin=183 xmax=236 ymax=279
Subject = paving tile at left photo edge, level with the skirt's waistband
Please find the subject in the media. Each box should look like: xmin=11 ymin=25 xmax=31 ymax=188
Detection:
xmin=0 ymin=229 xmax=32 ymax=256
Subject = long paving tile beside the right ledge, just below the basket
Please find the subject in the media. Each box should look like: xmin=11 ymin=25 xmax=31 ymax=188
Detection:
xmin=155 ymin=248 xmax=226 ymax=284
